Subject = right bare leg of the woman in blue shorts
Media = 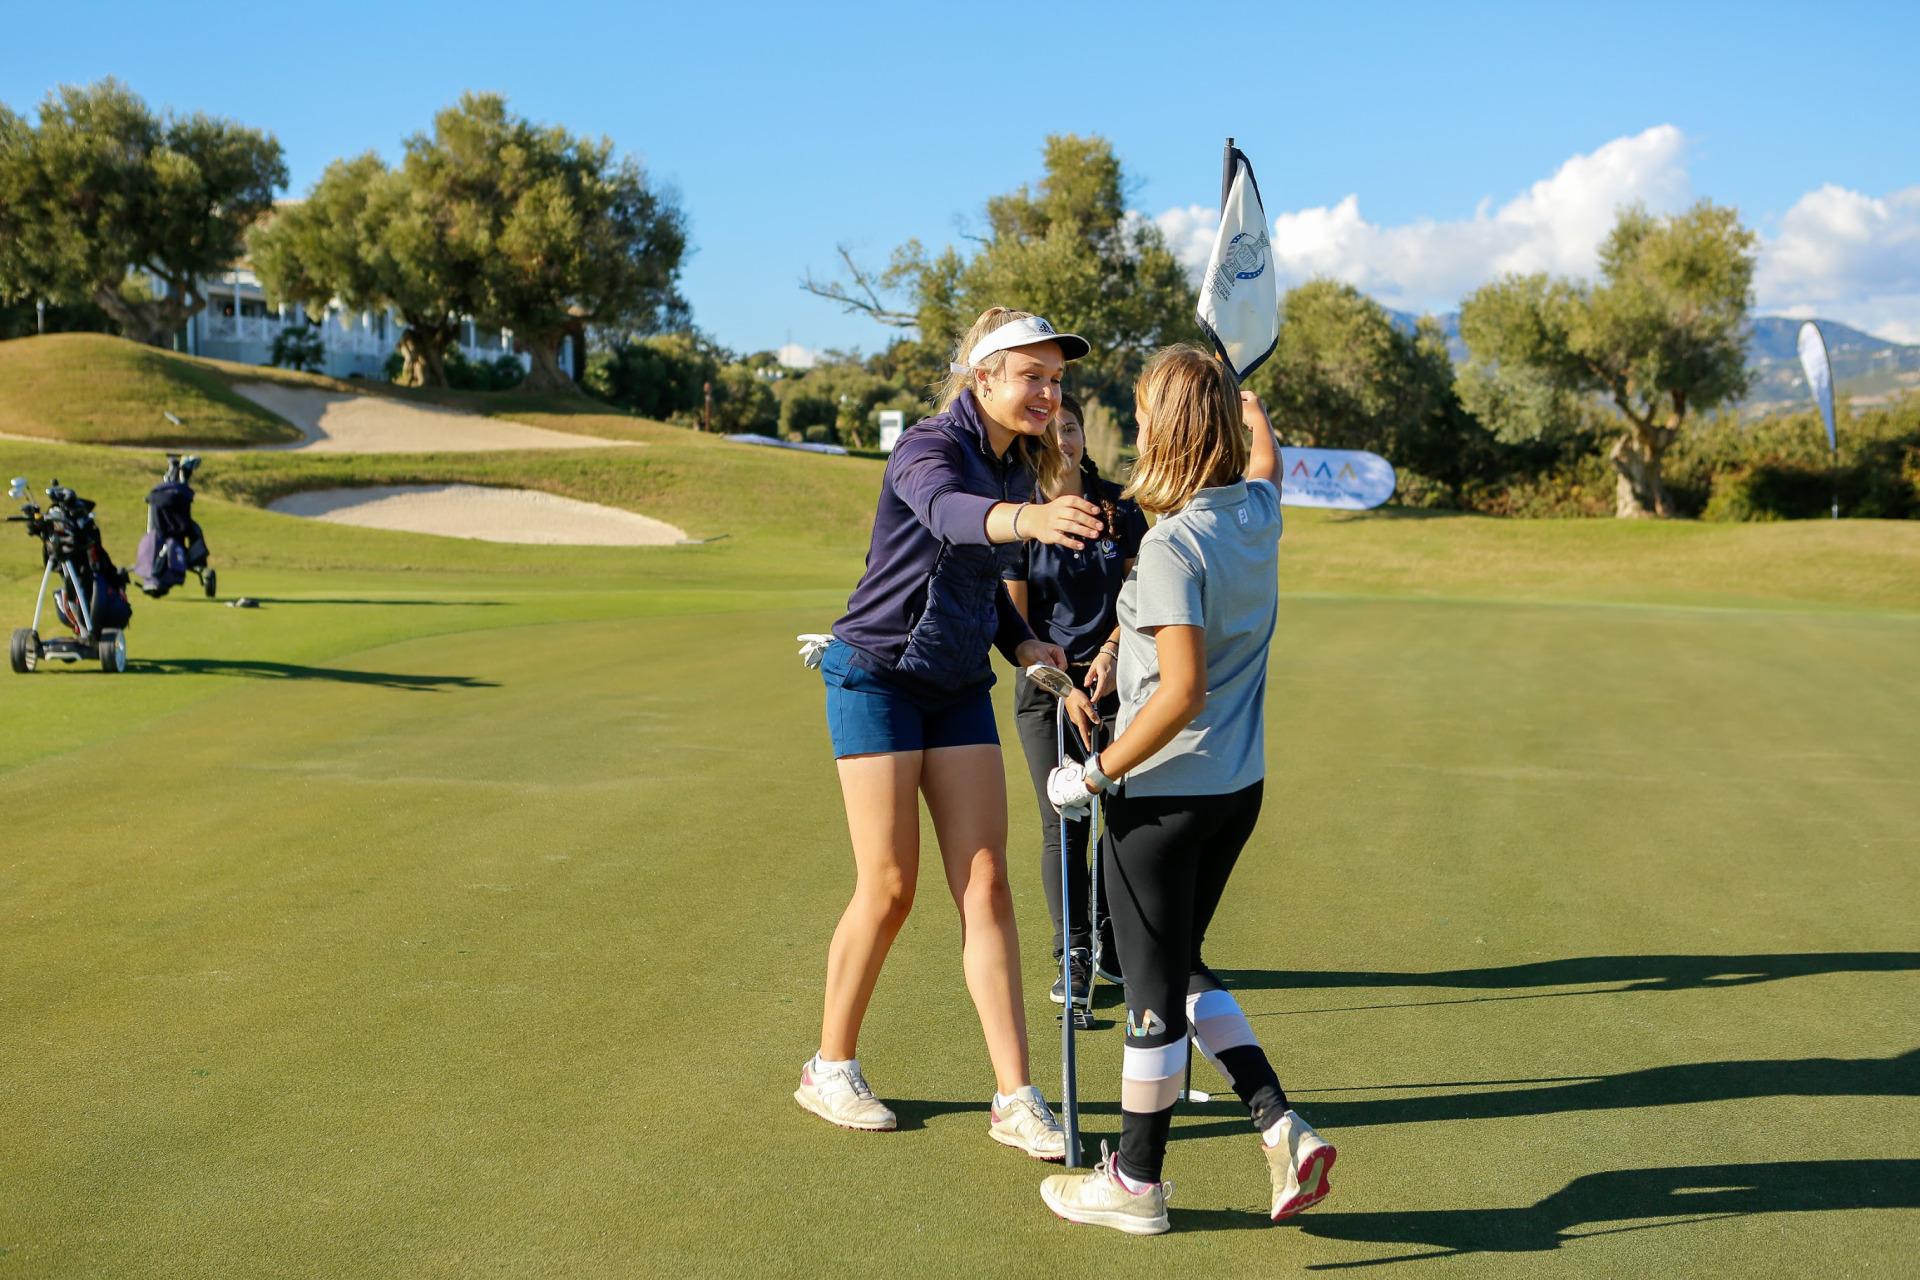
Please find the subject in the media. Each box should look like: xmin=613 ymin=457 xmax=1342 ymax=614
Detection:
xmin=920 ymin=745 xmax=1031 ymax=1094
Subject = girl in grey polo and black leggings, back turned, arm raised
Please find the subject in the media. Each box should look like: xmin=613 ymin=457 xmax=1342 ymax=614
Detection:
xmin=1041 ymin=347 xmax=1334 ymax=1236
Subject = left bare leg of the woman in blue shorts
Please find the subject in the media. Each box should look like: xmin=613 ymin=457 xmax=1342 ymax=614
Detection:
xmin=820 ymin=750 xmax=921 ymax=1061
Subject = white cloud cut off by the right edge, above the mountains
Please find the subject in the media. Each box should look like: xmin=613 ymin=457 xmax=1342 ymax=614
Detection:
xmin=1753 ymin=184 xmax=1920 ymax=342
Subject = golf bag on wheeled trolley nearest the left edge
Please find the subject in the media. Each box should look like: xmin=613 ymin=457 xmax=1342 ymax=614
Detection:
xmin=8 ymin=478 xmax=132 ymax=674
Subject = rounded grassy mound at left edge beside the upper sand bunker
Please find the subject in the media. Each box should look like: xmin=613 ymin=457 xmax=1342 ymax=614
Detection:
xmin=0 ymin=334 xmax=300 ymax=447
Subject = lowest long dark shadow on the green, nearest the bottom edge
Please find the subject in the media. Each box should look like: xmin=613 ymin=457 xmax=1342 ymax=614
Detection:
xmin=1294 ymin=1159 xmax=1920 ymax=1270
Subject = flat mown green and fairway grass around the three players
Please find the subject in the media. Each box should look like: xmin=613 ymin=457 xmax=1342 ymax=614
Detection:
xmin=0 ymin=441 xmax=1920 ymax=1276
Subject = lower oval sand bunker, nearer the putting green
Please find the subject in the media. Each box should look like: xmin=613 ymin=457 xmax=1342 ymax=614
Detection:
xmin=267 ymin=484 xmax=687 ymax=547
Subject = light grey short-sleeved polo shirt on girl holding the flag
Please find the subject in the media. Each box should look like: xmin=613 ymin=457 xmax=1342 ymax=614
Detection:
xmin=1119 ymin=480 xmax=1281 ymax=796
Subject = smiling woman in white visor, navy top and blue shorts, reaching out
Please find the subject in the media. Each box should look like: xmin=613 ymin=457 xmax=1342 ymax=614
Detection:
xmin=793 ymin=307 xmax=1104 ymax=1159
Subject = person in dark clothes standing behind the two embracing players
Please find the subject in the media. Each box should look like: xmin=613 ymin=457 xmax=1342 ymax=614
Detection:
xmin=1002 ymin=395 xmax=1146 ymax=1004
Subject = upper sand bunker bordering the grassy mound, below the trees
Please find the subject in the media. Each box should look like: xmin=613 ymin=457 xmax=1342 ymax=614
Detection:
xmin=234 ymin=382 xmax=637 ymax=453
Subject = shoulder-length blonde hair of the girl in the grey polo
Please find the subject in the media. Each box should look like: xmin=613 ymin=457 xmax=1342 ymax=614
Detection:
xmin=1125 ymin=344 xmax=1248 ymax=516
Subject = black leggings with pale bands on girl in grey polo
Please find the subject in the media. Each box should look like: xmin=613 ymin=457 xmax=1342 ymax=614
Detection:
xmin=1102 ymin=783 xmax=1286 ymax=1182
